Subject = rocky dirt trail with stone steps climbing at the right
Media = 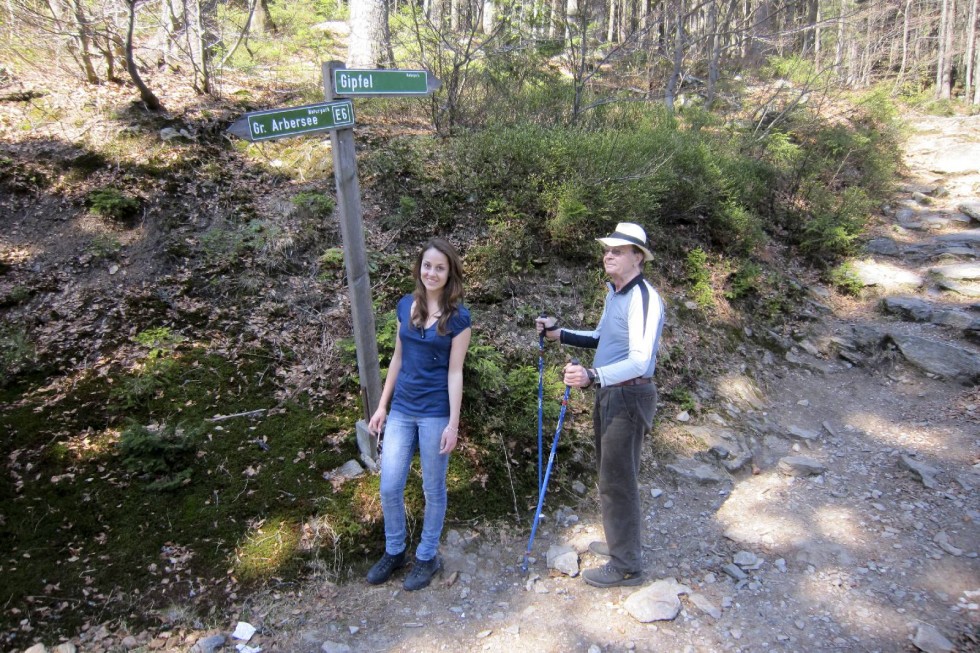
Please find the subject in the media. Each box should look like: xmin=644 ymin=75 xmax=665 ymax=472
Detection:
xmin=13 ymin=117 xmax=980 ymax=653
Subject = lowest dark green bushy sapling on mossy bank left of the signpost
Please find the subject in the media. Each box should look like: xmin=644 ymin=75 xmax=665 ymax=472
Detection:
xmin=119 ymin=424 xmax=202 ymax=491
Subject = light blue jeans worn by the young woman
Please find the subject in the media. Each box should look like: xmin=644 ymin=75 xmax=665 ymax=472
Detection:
xmin=381 ymin=411 xmax=449 ymax=560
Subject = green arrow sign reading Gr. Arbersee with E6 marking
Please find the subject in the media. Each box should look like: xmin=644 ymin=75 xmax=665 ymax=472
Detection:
xmin=228 ymin=100 xmax=354 ymax=141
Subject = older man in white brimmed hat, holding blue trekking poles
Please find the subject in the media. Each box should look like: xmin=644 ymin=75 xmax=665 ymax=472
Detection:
xmin=536 ymin=222 xmax=664 ymax=587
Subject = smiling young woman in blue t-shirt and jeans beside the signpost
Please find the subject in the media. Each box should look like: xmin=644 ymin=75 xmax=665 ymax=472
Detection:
xmin=367 ymin=238 xmax=470 ymax=591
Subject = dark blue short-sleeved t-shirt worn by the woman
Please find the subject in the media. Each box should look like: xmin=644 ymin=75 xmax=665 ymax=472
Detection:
xmin=391 ymin=295 xmax=470 ymax=417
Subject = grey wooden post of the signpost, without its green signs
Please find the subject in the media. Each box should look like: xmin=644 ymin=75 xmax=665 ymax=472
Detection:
xmin=322 ymin=61 xmax=381 ymax=460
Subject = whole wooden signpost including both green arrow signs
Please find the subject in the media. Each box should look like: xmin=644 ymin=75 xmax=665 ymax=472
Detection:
xmin=228 ymin=61 xmax=439 ymax=462
